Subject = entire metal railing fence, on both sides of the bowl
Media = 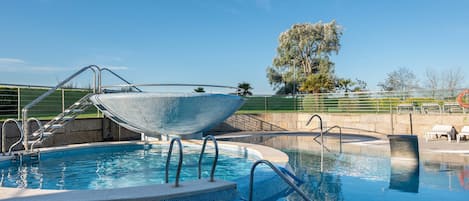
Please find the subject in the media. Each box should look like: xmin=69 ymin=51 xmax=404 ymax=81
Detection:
xmin=0 ymin=85 xmax=469 ymax=119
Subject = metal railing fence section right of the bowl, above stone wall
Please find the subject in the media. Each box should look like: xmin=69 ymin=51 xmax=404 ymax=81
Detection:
xmin=240 ymin=89 xmax=467 ymax=114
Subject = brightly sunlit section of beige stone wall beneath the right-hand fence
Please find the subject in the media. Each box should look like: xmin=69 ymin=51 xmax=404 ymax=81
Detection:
xmin=259 ymin=113 xmax=469 ymax=135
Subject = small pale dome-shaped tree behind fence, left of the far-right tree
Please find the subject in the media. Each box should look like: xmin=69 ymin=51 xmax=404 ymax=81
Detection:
xmin=378 ymin=67 xmax=418 ymax=92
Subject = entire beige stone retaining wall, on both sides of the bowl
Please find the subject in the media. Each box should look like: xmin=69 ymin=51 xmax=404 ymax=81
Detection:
xmin=0 ymin=113 xmax=469 ymax=147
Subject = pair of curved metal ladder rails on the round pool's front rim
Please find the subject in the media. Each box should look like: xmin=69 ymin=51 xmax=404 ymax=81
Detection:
xmin=165 ymin=135 xmax=218 ymax=187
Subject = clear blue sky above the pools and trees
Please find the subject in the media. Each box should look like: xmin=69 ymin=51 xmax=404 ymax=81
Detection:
xmin=0 ymin=0 xmax=469 ymax=94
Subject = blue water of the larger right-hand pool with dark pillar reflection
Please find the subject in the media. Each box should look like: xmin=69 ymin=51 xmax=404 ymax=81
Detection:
xmin=283 ymin=150 xmax=469 ymax=201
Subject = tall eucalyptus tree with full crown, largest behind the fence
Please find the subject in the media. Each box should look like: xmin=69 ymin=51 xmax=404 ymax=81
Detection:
xmin=267 ymin=21 xmax=342 ymax=92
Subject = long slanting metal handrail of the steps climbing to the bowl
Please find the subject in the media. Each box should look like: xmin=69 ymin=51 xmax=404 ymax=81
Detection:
xmin=21 ymin=65 xmax=101 ymax=151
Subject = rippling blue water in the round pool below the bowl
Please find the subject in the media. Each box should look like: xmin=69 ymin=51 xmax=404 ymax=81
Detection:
xmin=0 ymin=145 xmax=258 ymax=190
